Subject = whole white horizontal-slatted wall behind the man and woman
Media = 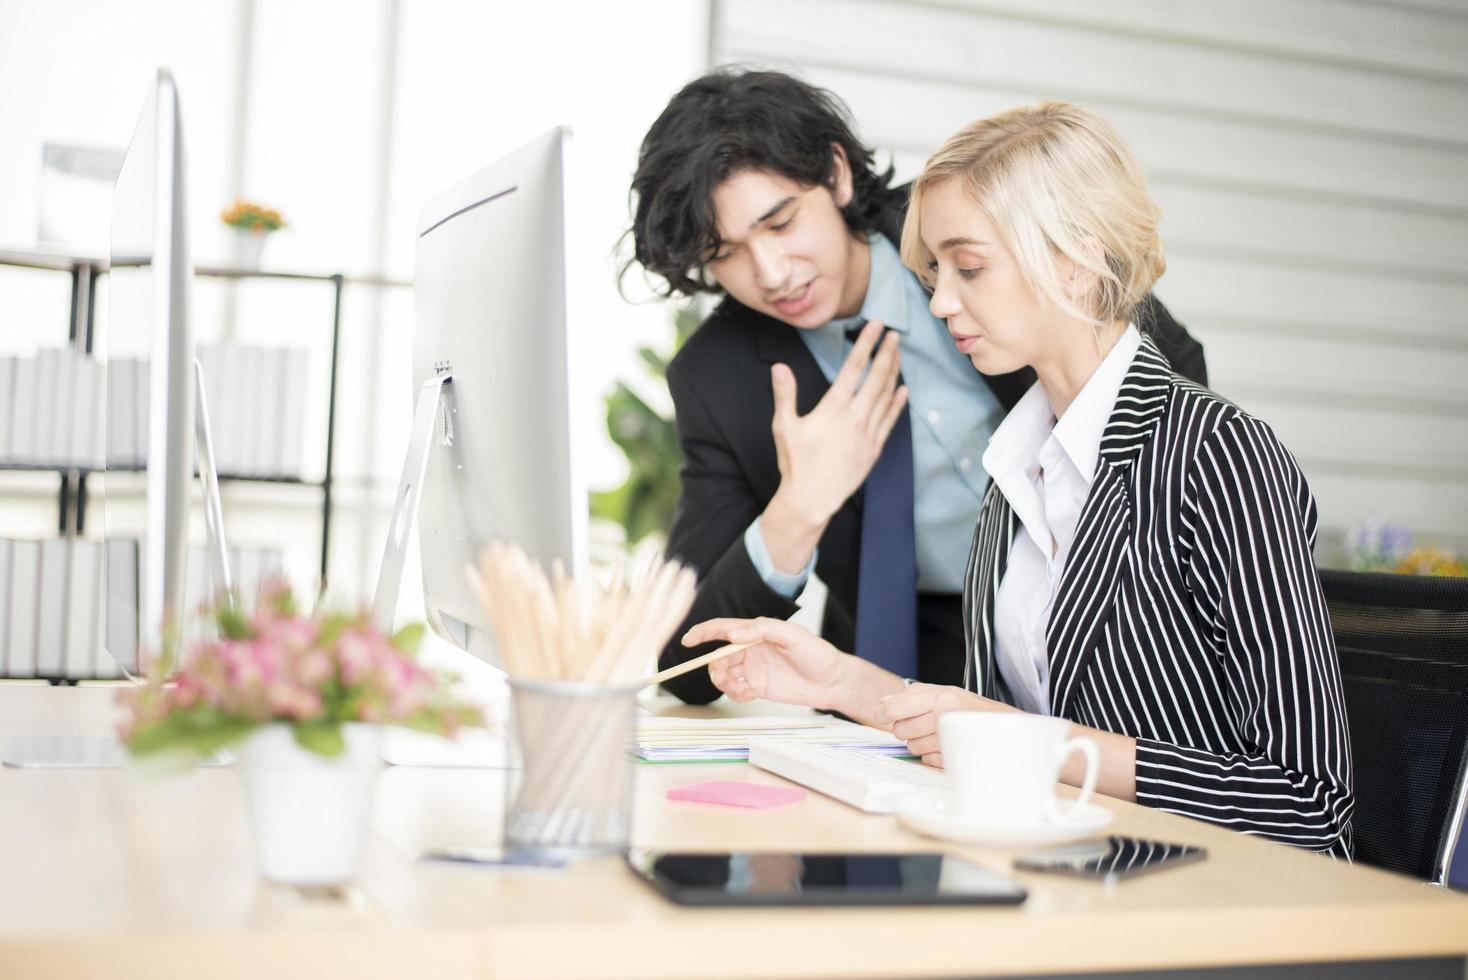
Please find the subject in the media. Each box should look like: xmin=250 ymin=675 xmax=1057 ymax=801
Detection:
xmin=713 ymin=0 xmax=1468 ymax=560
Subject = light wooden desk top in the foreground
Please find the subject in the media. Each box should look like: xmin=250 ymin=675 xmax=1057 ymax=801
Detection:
xmin=0 ymin=685 xmax=1468 ymax=980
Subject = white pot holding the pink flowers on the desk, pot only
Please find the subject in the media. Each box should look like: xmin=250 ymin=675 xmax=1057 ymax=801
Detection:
xmin=235 ymin=723 xmax=382 ymax=885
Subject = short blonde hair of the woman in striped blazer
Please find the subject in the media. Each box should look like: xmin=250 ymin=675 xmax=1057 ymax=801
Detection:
xmin=901 ymin=101 xmax=1167 ymax=327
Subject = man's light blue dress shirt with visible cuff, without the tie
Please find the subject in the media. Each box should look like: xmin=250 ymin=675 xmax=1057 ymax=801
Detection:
xmin=744 ymin=233 xmax=1004 ymax=599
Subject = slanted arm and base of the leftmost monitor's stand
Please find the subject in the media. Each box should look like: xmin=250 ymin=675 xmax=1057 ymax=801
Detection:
xmin=0 ymin=358 xmax=230 ymax=769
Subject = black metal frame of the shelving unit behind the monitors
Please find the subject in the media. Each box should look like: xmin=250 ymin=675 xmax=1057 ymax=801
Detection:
xmin=0 ymin=251 xmax=410 ymax=585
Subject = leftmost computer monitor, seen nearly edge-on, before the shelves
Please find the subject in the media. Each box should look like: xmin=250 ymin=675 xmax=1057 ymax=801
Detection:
xmin=104 ymin=69 xmax=228 ymax=673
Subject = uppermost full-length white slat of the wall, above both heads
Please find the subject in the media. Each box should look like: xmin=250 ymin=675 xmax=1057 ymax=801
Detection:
xmin=719 ymin=0 xmax=1468 ymax=145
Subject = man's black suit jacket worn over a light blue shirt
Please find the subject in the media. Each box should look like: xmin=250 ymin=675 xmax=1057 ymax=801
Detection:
xmin=658 ymin=189 xmax=1208 ymax=704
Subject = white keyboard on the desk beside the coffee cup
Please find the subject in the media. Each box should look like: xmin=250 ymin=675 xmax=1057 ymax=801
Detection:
xmin=749 ymin=738 xmax=948 ymax=813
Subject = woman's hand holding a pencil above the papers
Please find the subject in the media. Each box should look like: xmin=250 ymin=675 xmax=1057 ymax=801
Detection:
xmin=683 ymin=619 xmax=850 ymax=709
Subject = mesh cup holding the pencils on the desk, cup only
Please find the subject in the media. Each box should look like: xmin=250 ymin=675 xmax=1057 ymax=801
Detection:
xmin=505 ymin=681 xmax=639 ymax=858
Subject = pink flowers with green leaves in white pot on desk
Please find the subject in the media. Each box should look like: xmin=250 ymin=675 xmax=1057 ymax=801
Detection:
xmin=119 ymin=581 xmax=484 ymax=885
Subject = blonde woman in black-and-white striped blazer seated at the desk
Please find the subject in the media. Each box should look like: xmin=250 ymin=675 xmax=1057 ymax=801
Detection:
xmin=684 ymin=103 xmax=1352 ymax=857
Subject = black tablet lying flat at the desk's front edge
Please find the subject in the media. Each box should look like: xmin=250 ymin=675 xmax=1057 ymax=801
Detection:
xmin=627 ymin=848 xmax=1025 ymax=905
